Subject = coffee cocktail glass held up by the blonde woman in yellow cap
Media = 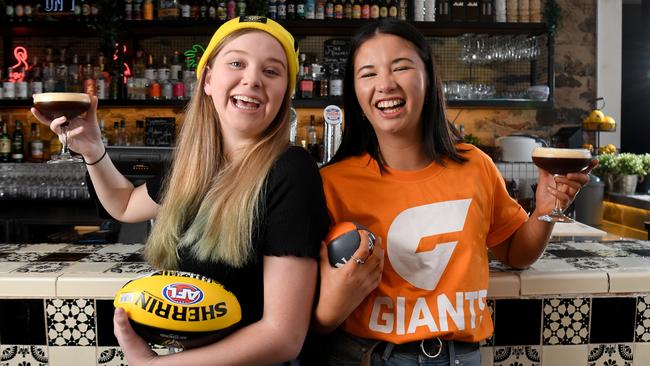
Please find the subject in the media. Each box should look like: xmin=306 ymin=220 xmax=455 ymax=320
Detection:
xmin=34 ymin=93 xmax=90 ymax=164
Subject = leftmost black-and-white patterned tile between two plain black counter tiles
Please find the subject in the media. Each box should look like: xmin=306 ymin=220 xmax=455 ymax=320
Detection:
xmin=45 ymin=299 xmax=97 ymax=346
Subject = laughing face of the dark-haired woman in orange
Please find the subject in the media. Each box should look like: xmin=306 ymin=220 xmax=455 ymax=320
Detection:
xmin=354 ymin=34 xmax=427 ymax=143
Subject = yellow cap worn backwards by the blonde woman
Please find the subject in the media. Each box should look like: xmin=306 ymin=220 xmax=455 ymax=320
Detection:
xmin=196 ymin=15 xmax=298 ymax=92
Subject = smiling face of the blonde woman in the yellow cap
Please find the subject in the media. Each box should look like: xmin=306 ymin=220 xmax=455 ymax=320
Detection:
xmin=203 ymin=31 xmax=289 ymax=150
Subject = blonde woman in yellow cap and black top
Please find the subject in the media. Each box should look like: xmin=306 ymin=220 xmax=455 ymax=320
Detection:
xmin=32 ymin=17 xmax=329 ymax=366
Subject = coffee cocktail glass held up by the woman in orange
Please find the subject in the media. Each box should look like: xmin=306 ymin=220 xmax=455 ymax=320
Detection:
xmin=533 ymin=147 xmax=591 ymax=222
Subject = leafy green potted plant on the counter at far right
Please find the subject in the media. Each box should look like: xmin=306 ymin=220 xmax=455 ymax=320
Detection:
xmin=594 ymin=153 xmax=647 ymax=194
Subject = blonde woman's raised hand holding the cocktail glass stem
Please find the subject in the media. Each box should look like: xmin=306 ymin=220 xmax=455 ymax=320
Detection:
xmin=31 ymin=96 xmax=104 ymax=161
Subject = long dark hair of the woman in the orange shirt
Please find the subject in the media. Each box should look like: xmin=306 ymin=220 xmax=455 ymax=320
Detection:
xmin=329 ymin=19 xmax=467 ymax=172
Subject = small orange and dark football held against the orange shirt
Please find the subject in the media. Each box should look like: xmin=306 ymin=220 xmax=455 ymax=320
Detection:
xmin=325 ymin=221 xmax=376 ymax=267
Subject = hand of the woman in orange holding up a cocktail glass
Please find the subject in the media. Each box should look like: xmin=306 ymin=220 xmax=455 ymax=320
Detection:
xmin=535 ymin=160 xmax=598 ymax=215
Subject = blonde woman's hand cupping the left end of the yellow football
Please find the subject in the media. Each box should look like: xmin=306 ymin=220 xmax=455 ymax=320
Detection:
xmin=113 ymin=308 xmax=157 ymax=366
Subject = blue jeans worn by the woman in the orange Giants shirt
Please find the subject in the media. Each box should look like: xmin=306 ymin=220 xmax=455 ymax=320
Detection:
xmin=322 ymin=331 xmax=481 ymax=366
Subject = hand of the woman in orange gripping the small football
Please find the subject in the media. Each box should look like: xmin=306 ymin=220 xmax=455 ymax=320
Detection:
xmin=314 ymin=231 xmax=384 ymax=333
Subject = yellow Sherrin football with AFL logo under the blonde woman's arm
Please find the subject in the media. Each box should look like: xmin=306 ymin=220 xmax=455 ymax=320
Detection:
xmin=113 ymin=271 xmax=241 ymax=349
